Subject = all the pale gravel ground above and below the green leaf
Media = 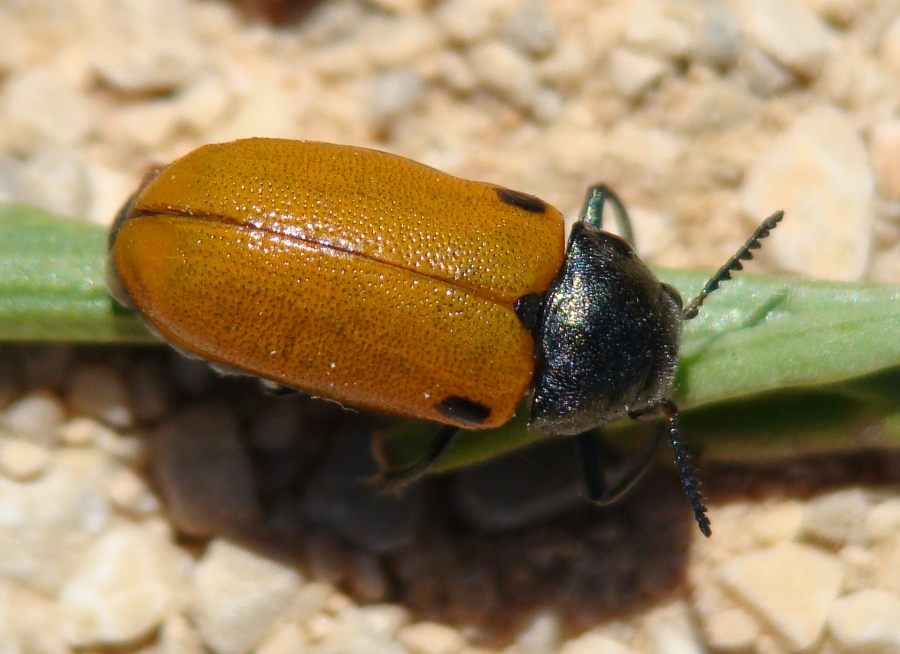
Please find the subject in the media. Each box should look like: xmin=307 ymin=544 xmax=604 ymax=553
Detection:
xmin=0 ymin=0 xmax=900 ymax=654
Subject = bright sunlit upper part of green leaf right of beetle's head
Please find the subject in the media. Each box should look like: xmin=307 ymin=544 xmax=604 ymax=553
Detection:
xmin=659 ymin=271 xmax=900 ymax=407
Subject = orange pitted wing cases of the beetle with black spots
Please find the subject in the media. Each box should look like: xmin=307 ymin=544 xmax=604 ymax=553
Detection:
xmin=110 ymin=139 xmax=564 ymax=428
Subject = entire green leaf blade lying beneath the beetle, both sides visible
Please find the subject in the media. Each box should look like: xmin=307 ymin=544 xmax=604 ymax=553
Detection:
xmin=0 ymin=204 xmax=900 ymax=472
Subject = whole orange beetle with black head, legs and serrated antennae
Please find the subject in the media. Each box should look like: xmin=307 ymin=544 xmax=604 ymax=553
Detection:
xmin=107 ymin=138 xmax=782 ymax=535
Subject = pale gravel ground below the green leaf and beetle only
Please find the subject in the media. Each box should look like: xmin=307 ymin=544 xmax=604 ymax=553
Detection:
xmin=0 ymin=366 xmax=900 ymax=654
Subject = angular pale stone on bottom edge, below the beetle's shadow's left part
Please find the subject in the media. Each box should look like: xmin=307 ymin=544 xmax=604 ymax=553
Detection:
xmin=190 ymin=540 xmax=303 ymax=654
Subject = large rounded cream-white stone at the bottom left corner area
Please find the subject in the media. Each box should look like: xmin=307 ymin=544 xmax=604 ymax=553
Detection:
xmin=60 ymin=525 xmax=180 ymax=647
